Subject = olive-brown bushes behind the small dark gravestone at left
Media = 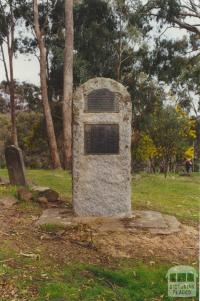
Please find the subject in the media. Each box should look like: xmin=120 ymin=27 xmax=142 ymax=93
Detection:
xmin=0 ymin=112 xmax=50 ymax=168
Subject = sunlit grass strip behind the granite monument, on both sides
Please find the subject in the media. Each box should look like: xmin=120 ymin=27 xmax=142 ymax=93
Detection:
xmin=0 ymin=170 xmax=200 ymax=223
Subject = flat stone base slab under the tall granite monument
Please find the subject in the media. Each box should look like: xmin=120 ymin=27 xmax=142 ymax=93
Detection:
xmin=36 ymin=208 xmax=181 ymax=235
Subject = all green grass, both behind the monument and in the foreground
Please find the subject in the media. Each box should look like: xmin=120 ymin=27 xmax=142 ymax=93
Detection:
xmin=0 ymin=170 xmax=200 ymax=301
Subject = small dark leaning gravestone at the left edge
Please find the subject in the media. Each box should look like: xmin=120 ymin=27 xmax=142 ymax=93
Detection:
xmin=5 ymin=145 xmax=26 ymax=185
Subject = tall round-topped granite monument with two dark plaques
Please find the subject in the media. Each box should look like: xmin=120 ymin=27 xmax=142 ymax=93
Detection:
xmin=73 ymin=78 xmax=132 ymax=217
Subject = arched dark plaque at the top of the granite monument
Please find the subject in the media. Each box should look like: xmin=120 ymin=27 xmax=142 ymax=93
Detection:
xmin=85 ymin=89 xmax=119 ymax=113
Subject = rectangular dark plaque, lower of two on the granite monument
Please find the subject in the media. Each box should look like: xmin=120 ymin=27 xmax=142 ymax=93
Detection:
xmin=85 ymin=124 xmax=119 ymax=155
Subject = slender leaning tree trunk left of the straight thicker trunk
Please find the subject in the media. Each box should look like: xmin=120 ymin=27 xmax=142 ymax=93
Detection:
xmin=33 ymin=0 xmax=61 ymax=169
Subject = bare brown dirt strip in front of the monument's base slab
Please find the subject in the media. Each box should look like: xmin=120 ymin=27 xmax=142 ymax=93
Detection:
xmin=0 ymin=205 xmax=198 ymax=264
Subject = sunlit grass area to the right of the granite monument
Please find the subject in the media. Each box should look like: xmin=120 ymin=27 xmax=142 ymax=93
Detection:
xmin=132 ymin=173 xmax=200 ymax=222
